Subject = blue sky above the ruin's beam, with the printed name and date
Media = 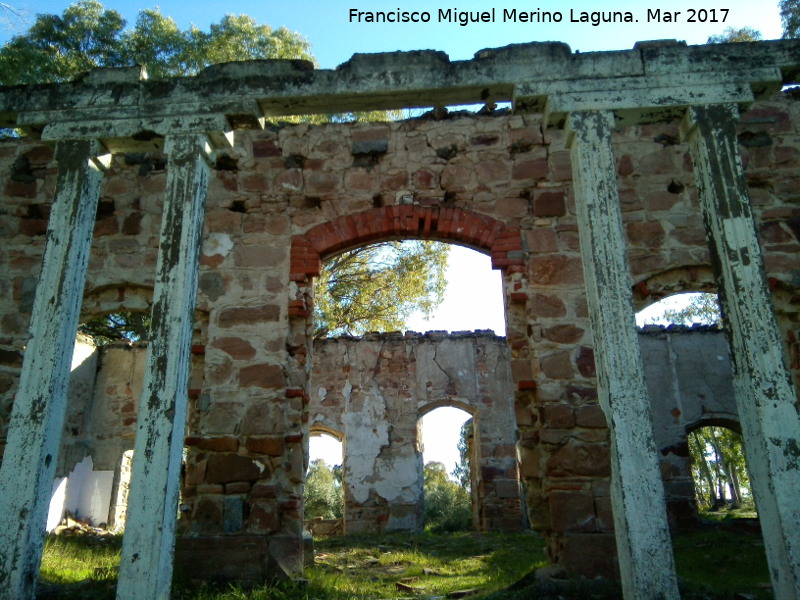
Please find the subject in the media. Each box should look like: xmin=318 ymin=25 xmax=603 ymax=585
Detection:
xmin=0 ymin=0 xmax=781 ymax=69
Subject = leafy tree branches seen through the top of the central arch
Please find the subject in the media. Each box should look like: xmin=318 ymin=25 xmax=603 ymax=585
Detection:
xmin=314 ymin=241 xmax=449 ymax=338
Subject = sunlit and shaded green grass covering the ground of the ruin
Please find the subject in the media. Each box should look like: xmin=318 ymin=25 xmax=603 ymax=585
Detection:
xmin=37 ymin=528 xmax=772 ymax=600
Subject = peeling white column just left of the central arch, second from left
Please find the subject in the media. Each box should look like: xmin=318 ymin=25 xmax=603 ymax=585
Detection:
xmin=117 ymin=135 xmax=209 ymax=600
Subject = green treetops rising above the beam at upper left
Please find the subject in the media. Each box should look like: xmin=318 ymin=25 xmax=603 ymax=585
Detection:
xmin=0 ymin=0 xmax=313 ymax=85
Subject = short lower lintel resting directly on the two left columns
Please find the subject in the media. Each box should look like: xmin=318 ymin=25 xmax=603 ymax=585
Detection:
xmin=36 ymin=113 xmax=233 ymax=153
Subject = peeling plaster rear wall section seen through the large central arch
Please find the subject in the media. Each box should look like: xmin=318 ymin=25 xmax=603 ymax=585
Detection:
xmin=309 ymin=333 xmax=522 ymax=532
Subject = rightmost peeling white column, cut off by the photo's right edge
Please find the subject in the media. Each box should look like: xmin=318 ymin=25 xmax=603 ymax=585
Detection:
xmin=683 ymin=104 xmax=800 ymax=600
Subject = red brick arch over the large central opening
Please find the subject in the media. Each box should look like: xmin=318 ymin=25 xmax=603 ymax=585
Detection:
xmin=291 ymin=204 xmax=525 ymax=282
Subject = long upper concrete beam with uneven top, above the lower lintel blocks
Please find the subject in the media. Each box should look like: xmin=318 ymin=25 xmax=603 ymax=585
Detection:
xmin=0 ymin=40 xmax=800 ymax=129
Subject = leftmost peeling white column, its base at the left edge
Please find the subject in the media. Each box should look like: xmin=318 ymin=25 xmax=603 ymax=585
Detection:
xmin=0 ymin=140 xmax=108 ymax=600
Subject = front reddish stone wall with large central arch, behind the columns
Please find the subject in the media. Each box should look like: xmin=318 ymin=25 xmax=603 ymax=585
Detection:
xmin=0 ymin=88 xmax=800 ymax=575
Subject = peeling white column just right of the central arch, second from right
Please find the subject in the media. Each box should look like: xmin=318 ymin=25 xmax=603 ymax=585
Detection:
xmin=567 ymin=111 xmax=679 ymax=600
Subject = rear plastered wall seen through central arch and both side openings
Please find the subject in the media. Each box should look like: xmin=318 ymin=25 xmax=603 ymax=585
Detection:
xmin=58 ymin=327 xmax=739 ymax=533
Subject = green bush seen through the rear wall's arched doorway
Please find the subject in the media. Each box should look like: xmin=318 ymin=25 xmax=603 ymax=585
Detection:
xmin=423 ymin=462 xmax=472 ymax=533
